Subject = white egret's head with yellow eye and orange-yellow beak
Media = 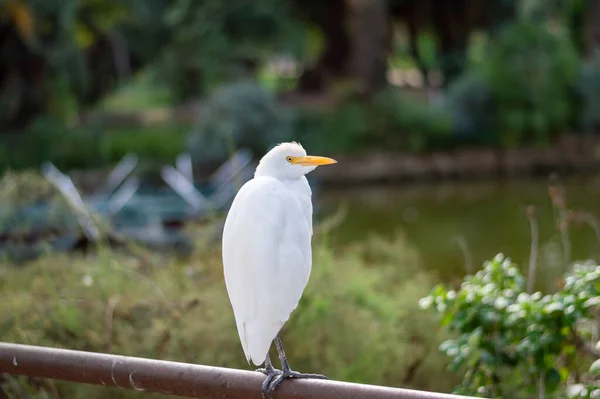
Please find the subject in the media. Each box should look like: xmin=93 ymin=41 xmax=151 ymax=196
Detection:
xmin=255 ymin=142 xmax=337 ymax=179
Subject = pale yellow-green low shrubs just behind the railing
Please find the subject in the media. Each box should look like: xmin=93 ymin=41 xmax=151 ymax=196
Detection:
xmin=0 ymin=225 xmax=454 ymax=399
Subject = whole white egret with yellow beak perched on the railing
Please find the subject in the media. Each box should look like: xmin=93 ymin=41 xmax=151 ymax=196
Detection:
xmin=223 ymin=142 xmax=336 ymax=397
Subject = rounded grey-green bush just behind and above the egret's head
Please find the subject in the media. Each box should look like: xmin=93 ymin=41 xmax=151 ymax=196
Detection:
xmin=189 ymin=82 xmax=292 ymax=161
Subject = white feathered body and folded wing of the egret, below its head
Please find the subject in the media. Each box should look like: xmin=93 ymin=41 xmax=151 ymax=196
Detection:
xmin=223 ymin=177 xmax=311 ymax=365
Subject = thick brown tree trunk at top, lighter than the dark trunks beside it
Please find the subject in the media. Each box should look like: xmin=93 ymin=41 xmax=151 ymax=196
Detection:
xmin=346 ymin=0 xmax=390 ymax=96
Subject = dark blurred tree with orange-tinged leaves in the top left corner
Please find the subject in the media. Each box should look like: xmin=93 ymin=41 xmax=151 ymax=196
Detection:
xmin=0 ymin=0 xmax=165 ymax=132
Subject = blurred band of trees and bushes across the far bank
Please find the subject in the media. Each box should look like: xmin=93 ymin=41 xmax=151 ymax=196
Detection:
xmin=0 ymin=0 xmax=600 ymax=168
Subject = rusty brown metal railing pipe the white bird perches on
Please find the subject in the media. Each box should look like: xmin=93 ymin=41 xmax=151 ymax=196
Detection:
xmin=0 ymin=343 xmax=478 ymax=399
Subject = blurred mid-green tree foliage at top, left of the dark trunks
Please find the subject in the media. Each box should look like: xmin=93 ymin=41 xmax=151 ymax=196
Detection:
xmin=159 ymin=0 xmax=305 ymax=99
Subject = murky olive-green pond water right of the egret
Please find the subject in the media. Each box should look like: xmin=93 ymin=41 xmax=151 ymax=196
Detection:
xmin=318 ymin=176 xmax=600 ymax=291
